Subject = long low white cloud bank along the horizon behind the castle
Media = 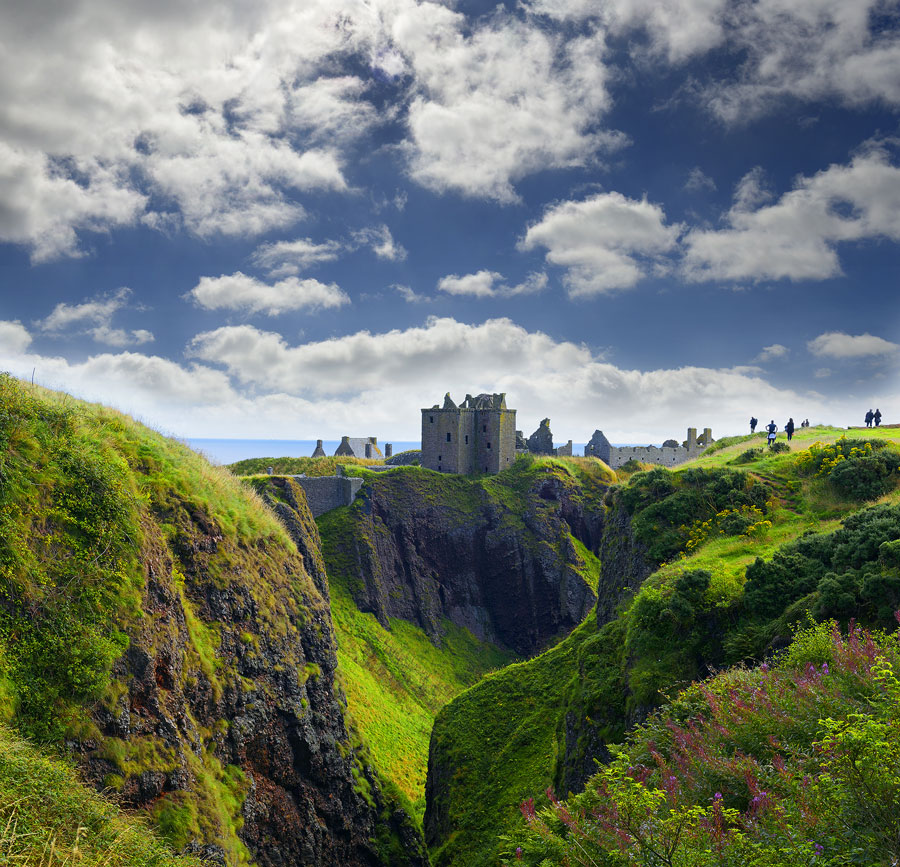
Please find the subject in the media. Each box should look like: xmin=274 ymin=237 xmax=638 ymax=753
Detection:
xmin=0 ymin=318 xmax=888 ymax=443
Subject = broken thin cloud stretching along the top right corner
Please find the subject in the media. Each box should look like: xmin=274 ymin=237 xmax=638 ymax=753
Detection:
xmin=525 ymin=0 xmax=900 ymax=122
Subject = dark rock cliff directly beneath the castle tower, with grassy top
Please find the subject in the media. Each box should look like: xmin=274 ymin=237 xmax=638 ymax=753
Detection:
xmin=323 ymin=459 xmax=608 ymax=654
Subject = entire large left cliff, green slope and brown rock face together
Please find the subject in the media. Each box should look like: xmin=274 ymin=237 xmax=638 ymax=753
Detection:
xmin=0 ymin=379 xmax=427 ymax=867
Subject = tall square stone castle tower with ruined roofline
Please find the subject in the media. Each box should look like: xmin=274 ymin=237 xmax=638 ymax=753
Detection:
xmin=420 ymin=392 xmax=516 ymax=476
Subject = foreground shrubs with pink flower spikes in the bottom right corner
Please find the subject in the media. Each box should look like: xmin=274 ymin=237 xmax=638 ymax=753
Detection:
xmin=503 ymin=623 xmax=900 ymax=867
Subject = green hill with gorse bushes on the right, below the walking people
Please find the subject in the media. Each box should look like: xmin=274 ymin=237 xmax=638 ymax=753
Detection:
xmin=426 ymin=429 xmax=900 ymax=867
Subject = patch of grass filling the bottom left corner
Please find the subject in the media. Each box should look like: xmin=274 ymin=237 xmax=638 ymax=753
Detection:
xmin=0 ymin=726 xmax=201 ymax=867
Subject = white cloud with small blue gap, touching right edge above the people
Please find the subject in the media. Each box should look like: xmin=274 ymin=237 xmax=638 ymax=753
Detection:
xmin=683 ymin=143 xmax=900 ymax=281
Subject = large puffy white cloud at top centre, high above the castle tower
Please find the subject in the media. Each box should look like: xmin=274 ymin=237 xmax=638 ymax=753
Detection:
xmin=391 ymin=11 xmax=626 ymax=202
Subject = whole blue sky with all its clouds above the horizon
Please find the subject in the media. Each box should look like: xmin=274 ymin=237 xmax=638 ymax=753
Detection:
xmin=0 ymin=0 xmax=900 ymax=442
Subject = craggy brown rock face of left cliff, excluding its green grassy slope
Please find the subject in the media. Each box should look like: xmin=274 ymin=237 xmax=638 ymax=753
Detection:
xmin=82 ymin=478 xmax=428 ymax=867
